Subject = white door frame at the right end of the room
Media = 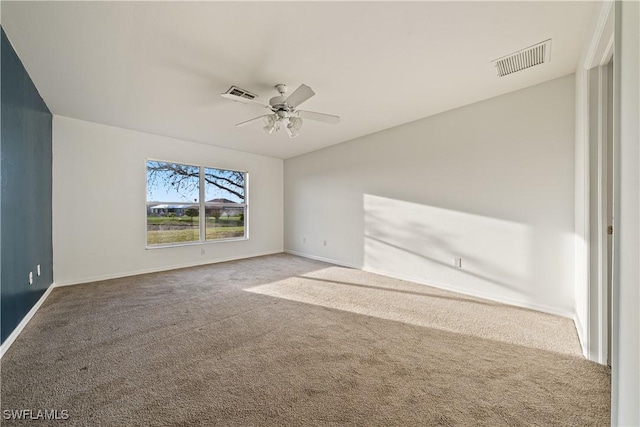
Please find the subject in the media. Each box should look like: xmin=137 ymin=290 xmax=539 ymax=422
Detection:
xmin=576 ymin=0 xmax=617 ymax=364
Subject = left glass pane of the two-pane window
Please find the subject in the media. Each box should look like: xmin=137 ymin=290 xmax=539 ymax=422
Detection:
xmin=147 ymin=161 xmax=200 ymax=245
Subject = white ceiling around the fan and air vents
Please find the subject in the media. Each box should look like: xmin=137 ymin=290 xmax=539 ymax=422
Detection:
xmin=2 ymin=1 xmax=596 ymax=158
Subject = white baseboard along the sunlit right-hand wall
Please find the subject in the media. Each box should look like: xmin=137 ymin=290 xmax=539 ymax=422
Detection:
xmin=285 ymin=249 xmax=575 ymax=320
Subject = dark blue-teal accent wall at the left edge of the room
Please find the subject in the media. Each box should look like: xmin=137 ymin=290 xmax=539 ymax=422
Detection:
xmin=0 ymin=29 xmax=53 ymax=342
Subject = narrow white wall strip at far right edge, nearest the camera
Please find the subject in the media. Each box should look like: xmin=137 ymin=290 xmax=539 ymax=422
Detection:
xmin=611 ymin=1 xmax=640 ymax=426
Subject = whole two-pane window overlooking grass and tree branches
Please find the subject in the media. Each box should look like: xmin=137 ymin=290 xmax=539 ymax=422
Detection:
xmin=147 ymin=160 xmax=247 ymax=246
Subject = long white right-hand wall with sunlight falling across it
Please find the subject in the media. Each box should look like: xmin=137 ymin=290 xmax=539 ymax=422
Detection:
xmin=285 ymin=76 xmax=575 ymax=316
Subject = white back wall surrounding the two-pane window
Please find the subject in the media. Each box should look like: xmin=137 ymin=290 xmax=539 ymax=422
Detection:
xmin=53 ymin=116 xmax=283 ymax=284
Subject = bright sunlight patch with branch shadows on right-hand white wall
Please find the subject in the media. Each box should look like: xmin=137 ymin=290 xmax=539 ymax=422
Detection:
xmin=363 ymin=194 xmax=535 ymax=306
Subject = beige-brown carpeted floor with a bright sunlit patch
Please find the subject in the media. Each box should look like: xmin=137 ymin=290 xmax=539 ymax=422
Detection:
xmin=1 ymin=254 xmax=610 ymax=426
